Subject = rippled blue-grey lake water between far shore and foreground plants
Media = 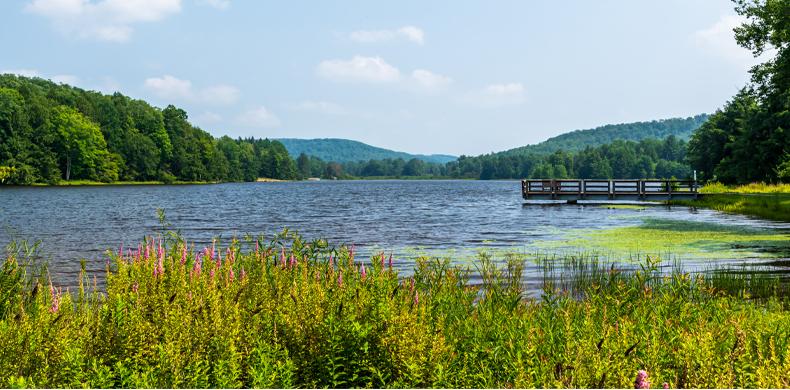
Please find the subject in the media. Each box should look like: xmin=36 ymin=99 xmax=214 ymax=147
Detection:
xmin=0 ymin=180 xmax=790 ymax=285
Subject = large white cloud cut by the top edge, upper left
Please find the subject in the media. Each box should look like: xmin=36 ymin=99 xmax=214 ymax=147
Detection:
xmin=25 ymin=0 xmax=181 ymax=42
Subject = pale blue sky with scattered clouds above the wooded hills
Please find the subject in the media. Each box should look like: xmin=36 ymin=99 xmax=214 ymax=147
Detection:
xmin=0 ymin=0 xmax=755 ymax=155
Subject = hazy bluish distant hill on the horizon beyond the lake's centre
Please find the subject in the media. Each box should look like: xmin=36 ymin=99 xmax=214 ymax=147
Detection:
xmin=277 ymin=138 xmax=457 ymax=164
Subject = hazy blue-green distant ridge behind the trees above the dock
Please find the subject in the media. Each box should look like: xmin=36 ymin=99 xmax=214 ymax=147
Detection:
xmin=494 ymin=114 xmax=708 ymax=156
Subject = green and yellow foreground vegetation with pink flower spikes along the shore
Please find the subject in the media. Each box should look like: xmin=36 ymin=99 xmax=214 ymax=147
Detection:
xmin=0 ymin=234 xmax=790 ymax=388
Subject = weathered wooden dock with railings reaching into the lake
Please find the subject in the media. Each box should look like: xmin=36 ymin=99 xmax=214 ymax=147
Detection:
xmin=521 ymin=179 xmax=699 ymax=202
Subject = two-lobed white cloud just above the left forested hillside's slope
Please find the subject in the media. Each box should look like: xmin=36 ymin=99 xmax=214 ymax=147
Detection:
xmin=143 ymin=75 xmax=239 ymax=105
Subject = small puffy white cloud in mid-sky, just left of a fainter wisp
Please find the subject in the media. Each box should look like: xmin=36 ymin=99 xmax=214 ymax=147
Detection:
xmin=316 ymin=56 xmax=400 ymax=83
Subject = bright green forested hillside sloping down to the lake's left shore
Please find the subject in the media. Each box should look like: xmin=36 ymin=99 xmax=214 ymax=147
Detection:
xmin=0 ymin=74 xmax=297 ymax=184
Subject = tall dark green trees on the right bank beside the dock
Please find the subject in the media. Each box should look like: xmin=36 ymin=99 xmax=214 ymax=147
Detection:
xmin=688 ymin=0 xmax=790 ymax=184
